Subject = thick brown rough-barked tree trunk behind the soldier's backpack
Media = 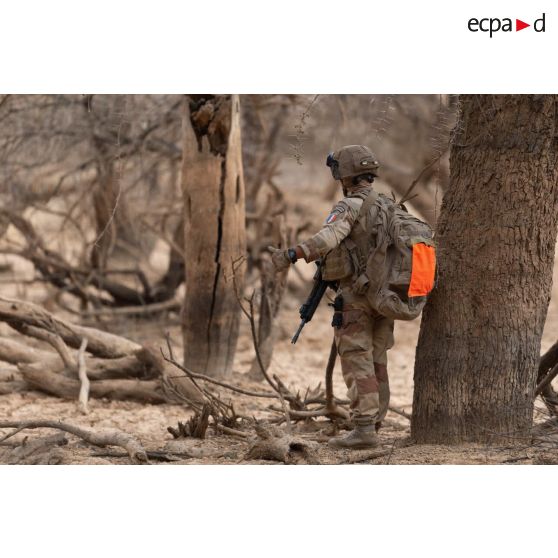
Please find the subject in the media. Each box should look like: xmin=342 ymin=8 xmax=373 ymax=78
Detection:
xmin=411 ymin=95 xmax=558 ymax=444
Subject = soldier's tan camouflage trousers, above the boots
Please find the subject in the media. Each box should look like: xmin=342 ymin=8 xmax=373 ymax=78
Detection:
xmin=334 ymin=289 xmax=394 ymax=422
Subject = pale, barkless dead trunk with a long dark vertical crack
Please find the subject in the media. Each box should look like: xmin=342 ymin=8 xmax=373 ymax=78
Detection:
xmin=182 ymin=95 xmax=246 ymax=376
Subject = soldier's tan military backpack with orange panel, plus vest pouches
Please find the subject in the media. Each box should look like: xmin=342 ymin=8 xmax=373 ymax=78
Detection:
xmin=322 ymin=190 xmax=436 ymax=320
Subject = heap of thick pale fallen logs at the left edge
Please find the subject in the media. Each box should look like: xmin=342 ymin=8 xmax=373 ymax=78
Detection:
xmin=0 ymin=302 xmax=204 ymax=406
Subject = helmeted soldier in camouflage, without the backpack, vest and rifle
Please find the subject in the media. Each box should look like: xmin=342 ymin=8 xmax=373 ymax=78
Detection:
xmin=270 ymin=145 xmax=394 ymax=449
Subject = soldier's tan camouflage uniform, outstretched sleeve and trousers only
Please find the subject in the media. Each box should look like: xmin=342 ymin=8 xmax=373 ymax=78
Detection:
xmin=299 ymin=183 xmax=394 ymax=422
